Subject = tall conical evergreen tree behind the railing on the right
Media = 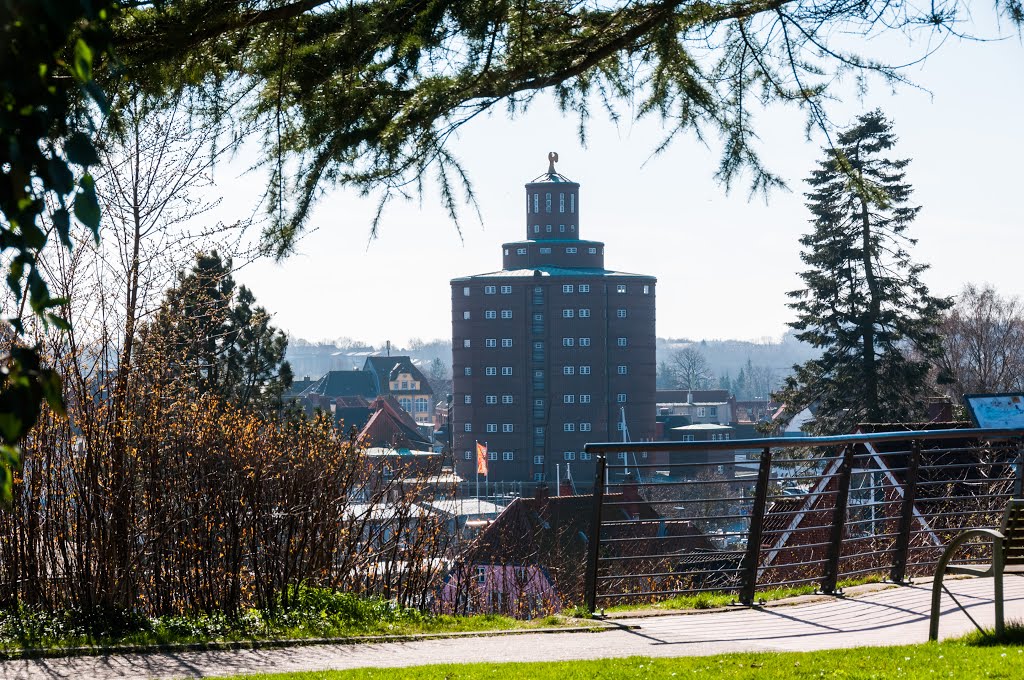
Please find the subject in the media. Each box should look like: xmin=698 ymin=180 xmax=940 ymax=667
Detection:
xmin=776 ymin=111 xmax=950 ymax=433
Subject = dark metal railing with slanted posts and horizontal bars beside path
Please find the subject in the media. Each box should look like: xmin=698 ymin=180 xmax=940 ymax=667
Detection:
xmin=585 ymin=429 xmax=1024 ymax=611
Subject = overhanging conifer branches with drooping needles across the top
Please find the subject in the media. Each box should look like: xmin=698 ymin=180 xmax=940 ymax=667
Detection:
xmin=108 ymin=0 xmax=1020 ymax=255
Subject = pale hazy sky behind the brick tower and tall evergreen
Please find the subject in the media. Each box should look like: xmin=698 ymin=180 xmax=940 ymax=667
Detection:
xmin=218 ymin=19 xmax=1024 ymax=344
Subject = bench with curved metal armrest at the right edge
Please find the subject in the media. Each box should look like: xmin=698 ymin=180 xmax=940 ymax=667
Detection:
xmin=928 ymin=499 xmax=1024 ymax=640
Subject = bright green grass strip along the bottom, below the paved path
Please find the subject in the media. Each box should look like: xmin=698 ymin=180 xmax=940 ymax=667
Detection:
xmin=209 ymin=640 xmax=1024 ymax=680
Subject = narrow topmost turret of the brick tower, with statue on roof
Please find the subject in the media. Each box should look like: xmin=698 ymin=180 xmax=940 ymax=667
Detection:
xmin=526 ymin=152 xmax=580 ymax=241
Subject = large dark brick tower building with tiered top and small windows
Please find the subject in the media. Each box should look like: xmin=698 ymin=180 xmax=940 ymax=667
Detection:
xmin=452 ymin=154 xmax=656 ymax=486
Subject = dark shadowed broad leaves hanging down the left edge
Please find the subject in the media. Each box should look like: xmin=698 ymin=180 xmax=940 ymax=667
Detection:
xmin=0 ymin=0 xmax=115 ymax=500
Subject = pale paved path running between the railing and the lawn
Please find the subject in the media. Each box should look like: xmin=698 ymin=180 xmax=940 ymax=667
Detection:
xmin=0 ymin=577 xmax=1024 ymax=680
